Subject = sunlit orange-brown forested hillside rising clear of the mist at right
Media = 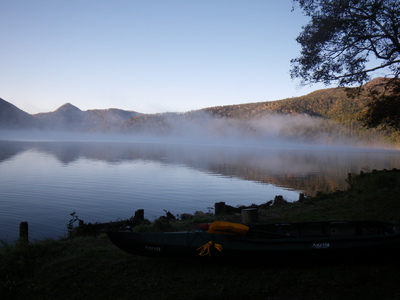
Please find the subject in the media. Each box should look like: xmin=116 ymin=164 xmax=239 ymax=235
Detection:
xmin=203 ymin=78 xmax=400 ymax=144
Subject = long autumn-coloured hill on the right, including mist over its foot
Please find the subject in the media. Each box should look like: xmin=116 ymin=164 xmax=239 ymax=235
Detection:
xmin=119 ymin=78 xmax=400 ymax=145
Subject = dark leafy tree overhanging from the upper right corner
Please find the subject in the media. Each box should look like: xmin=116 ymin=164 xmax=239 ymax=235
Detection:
xmin=291 ymin=0 xmax=400 ymax=127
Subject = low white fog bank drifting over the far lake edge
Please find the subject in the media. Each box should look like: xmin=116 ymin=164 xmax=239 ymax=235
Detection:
xmin=0 ymin=111 xmax=389 ymax=149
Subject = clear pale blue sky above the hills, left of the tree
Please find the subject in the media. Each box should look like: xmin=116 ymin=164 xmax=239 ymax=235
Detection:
xmin=0 ymin=0 xmax=325 ymax=114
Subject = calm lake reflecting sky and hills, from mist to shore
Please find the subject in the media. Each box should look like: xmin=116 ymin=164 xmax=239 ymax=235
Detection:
xmin=0 ymin=141 xmax=400 ymax=242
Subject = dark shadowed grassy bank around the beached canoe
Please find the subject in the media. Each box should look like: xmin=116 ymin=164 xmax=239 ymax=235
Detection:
xmin=0 ymin=171 xmax=400 ymax=299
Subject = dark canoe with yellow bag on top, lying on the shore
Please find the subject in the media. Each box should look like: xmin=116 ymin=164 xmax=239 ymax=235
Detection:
xmin=107 ymin=221 xmax=400 ymax=260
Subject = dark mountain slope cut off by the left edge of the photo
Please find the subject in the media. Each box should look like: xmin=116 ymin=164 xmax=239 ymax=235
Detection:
xmin=0 ymin=98 xmax=36 ymax=129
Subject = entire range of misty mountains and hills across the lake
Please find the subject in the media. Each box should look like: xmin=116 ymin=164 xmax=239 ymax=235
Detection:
xmin=0 ymin=78 xmax=400 ymax=144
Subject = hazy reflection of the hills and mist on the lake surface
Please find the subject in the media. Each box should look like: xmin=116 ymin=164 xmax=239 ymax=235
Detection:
xmin=0 ymin=142 xmax=400 ymax=195
